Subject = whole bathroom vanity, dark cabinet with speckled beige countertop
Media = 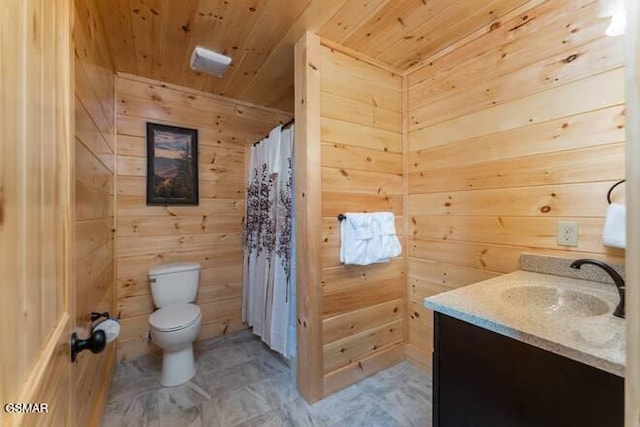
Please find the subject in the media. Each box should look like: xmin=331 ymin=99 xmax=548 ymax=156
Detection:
xmin=425 ymin=271 xmax=624 ymax=427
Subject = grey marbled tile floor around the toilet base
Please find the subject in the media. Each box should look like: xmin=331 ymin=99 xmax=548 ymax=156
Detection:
xmin=103 ymin=331 xmax=431 ymax=427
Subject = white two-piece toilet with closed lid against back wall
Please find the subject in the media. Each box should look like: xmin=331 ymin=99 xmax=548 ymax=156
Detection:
xmin=149 ymin=263 xmax=202 ymax=386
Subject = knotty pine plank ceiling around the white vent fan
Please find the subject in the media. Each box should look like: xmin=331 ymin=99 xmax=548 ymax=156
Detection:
xmin=97 ymin=0 xmax=540 ymax=111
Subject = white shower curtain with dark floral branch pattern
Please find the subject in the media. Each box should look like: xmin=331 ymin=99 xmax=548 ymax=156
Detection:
xmin=242 ymin=126 xmax=295 ymax=358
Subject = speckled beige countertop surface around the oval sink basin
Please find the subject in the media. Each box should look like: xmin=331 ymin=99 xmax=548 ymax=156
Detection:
xmin=424 ymin=271 xmax=625 ymax=377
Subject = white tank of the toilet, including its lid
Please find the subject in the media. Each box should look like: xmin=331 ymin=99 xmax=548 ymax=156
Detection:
xmin=149 ymin=262 xmax=200 ymax=308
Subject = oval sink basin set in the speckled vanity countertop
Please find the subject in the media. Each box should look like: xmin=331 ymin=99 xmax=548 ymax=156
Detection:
xmin=500 ymin=285 xmax=611 ymax=317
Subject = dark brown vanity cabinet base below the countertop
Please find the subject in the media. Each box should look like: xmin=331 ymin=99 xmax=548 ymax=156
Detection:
xmin=433 ymin=313 xmax=624 ymax=427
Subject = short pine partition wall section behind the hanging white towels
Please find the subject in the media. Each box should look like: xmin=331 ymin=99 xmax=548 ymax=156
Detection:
xmin=320 ymin=42 xmax=405 ymax=396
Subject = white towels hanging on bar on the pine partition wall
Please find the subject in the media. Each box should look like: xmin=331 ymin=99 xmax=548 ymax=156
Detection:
xmin=340 ymin=212 xmax=402 ymax=265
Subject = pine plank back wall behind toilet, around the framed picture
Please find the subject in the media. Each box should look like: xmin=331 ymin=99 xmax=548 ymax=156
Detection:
xmin=116 ymin=75 xmax=291 ymax=360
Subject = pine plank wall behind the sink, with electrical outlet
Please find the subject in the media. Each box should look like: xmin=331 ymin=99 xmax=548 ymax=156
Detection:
xmin=407 ymin=0 xmax=625 ymax=366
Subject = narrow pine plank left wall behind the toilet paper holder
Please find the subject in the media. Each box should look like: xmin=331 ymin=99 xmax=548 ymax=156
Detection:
xmin=73 ymin=0 xmax=116 ymax=425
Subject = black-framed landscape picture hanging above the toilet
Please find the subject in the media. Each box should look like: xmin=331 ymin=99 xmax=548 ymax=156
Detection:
xmin=147 ymin=123 xmax=198 ymax=205
